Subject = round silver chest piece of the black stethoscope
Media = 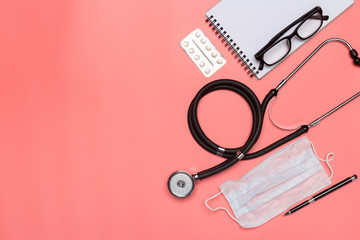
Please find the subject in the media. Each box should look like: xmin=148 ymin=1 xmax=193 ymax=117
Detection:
xmin=168 ymin=171 xmax=195 ymax=198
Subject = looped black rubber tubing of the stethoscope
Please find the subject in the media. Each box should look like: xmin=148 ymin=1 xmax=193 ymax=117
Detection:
xmin=188 ymin=79 xmax=309 ymax=180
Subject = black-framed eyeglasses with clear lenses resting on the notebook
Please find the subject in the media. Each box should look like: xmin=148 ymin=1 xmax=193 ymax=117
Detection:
xmin=255 ymin=6 xmax=329 ymax=70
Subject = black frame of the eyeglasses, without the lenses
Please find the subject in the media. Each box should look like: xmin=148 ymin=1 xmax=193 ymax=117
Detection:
xmin=254 ymin=6 xmax=329 ymax=70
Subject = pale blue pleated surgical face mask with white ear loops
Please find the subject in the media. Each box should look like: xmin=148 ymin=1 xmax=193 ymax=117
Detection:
xmin=205 ymin=137 xmax=333 ymax=228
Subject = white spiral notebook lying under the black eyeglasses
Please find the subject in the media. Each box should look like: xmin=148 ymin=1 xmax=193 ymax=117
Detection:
xmin=206 ymin=0 xmax=354 ymax=79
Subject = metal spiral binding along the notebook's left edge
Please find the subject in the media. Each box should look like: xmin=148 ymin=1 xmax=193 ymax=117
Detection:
xmin=205 ymin=15 xmax=259 ymax=78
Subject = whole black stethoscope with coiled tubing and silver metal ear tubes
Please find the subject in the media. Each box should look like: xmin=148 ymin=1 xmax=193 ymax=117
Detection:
xmin=168 ymin=38 xmax=360 ymax=198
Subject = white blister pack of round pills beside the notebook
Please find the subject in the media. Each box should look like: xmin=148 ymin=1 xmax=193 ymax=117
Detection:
xmin=180 ymin=28 xmax=226 ymax=77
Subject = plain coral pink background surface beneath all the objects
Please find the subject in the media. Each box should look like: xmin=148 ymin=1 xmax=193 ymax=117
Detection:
xmin=0 ymin=0 xmax=360 ymax=240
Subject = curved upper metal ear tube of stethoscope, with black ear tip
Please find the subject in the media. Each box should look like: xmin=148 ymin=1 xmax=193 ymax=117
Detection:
xmin=276 ymin=38 xmax=360 ymax=90
